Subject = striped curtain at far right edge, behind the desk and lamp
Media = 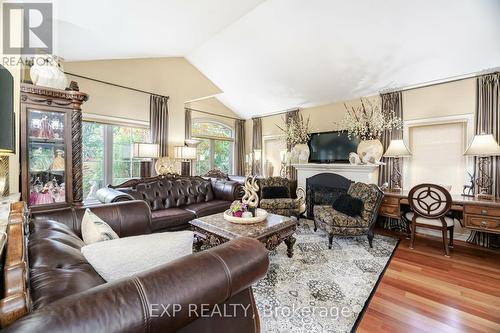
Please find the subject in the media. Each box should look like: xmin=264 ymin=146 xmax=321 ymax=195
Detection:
xmin=468 ymin=72 xmax=500 ymax=247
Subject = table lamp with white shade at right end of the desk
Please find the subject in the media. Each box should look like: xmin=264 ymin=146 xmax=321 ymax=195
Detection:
xmin=464 ymin=134 xmax=500 ymax=200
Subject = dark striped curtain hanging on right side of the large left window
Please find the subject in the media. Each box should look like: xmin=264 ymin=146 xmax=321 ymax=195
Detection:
xmin=149 ymin=95 xmax=168 ymax=157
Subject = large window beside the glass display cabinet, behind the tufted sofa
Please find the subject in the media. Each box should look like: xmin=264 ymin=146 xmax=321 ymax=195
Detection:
xmin=83 ymin=121 xmax=149 ymax=199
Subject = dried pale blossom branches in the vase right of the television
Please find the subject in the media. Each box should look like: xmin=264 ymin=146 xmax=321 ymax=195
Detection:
xmin=335 ymin=98 xmax=403 ymax=140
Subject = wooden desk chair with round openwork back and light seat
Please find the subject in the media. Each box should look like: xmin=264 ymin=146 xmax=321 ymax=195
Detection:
xmin=405 ymin=184 xmax=455 ymax=257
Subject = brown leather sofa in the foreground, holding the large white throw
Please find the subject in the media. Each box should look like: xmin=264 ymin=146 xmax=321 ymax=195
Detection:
xmin=5 ymin=201 xmax=269 ymax=333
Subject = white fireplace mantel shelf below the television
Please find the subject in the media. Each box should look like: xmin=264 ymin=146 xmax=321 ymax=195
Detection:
xmin=292 ymin=163 xmax=379 ymax=189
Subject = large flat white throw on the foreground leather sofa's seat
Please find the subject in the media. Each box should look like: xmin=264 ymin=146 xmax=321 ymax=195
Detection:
xmin=82 ymin=231 xmax=194 ymax=281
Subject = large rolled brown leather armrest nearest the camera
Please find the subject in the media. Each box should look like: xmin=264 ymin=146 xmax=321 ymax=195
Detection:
xmin=6 ymin=238 xmax=269 ymax=333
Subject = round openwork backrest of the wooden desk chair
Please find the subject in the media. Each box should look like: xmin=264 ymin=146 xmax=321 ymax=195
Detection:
xmin=408 ymin=184 xmax=452 ymax=219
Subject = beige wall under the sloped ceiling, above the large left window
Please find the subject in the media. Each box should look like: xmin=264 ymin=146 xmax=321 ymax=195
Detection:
xmin=64 ymin=58 xmax=221 ymax=153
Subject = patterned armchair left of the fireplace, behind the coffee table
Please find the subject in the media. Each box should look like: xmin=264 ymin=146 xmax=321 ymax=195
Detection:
xmin=259 ymin=177 xmax=305 ymax=218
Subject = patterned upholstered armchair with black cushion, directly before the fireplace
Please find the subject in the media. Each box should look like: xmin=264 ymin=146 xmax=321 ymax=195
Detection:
xmin=313 ymin=183 xmax=384 ymax=249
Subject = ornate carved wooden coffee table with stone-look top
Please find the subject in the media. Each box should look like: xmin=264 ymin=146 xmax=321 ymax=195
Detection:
xmin=189 ymin=213 xmax=297 ymax=258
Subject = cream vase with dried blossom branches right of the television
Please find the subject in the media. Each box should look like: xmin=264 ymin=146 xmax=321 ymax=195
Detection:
xmin=335 ymin=98 xmax=403 ymax=162
